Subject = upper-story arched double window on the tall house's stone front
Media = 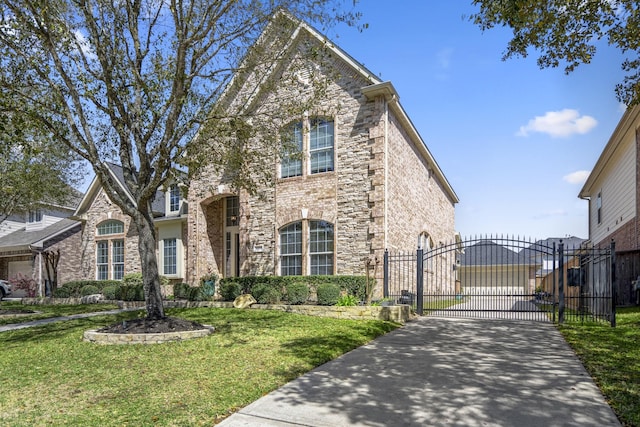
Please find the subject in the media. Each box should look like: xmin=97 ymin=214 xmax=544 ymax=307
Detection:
xmin=280 ymin=118 xmax=335 ymax=178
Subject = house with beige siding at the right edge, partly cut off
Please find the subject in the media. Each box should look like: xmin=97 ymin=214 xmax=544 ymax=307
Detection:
xmin=579 ymin=105 xmax=640 ymax=305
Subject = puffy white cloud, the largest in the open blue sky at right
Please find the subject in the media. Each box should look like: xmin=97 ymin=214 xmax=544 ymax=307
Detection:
xmin=516 ymin=108 xmax=598 ymax=138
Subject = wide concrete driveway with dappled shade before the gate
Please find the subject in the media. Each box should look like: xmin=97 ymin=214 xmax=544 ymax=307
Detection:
xmin=219 ymin=317 xmax=620 ymax=427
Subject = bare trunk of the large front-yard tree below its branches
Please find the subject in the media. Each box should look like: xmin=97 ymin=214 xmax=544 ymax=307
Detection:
xmin=134 ymin=212 xmax=165 ymax=320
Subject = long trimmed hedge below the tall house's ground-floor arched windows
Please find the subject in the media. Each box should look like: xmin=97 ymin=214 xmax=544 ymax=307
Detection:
xmin=220 ymin=276 xmax=367 ymax=304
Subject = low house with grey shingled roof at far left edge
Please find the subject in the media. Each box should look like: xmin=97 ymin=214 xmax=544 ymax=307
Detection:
xmin=0 ymin=198 xmax=80 ymax=297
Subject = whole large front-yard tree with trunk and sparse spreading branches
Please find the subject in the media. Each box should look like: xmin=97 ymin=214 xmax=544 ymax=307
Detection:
xmin=0 ymin=0 xmax=358 ymax=318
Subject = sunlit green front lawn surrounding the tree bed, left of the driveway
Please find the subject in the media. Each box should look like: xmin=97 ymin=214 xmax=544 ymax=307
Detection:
xmin=0 ymin=306 xmax=397 ymax=426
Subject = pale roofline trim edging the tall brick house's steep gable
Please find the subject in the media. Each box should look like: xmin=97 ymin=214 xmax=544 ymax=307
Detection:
xmin=221 ymin=10 xmax=460 ymax=203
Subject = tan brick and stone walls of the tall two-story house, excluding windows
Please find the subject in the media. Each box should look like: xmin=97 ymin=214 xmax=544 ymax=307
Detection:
xmin=188 ymin=27 xmax=454 ymax=290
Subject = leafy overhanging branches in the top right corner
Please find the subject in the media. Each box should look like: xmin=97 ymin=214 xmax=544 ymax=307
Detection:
xmin=471 ymin=0 xmax=640 ymax=106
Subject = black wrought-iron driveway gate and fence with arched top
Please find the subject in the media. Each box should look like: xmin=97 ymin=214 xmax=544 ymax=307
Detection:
xmin=383 ymin=236 xmax=615 ymax=326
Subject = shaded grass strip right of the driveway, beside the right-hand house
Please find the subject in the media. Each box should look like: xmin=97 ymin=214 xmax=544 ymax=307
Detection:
xmin=559 ymin=307 xmax=640 ymax=426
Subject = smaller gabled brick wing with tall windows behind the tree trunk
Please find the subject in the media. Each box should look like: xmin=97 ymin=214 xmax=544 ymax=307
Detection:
xmin=73 ymin=164 xmax=188 ymax=288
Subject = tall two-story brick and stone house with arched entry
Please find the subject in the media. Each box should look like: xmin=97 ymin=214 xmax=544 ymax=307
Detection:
xmin=187 ymin=15 xmax=458 ymax=292
